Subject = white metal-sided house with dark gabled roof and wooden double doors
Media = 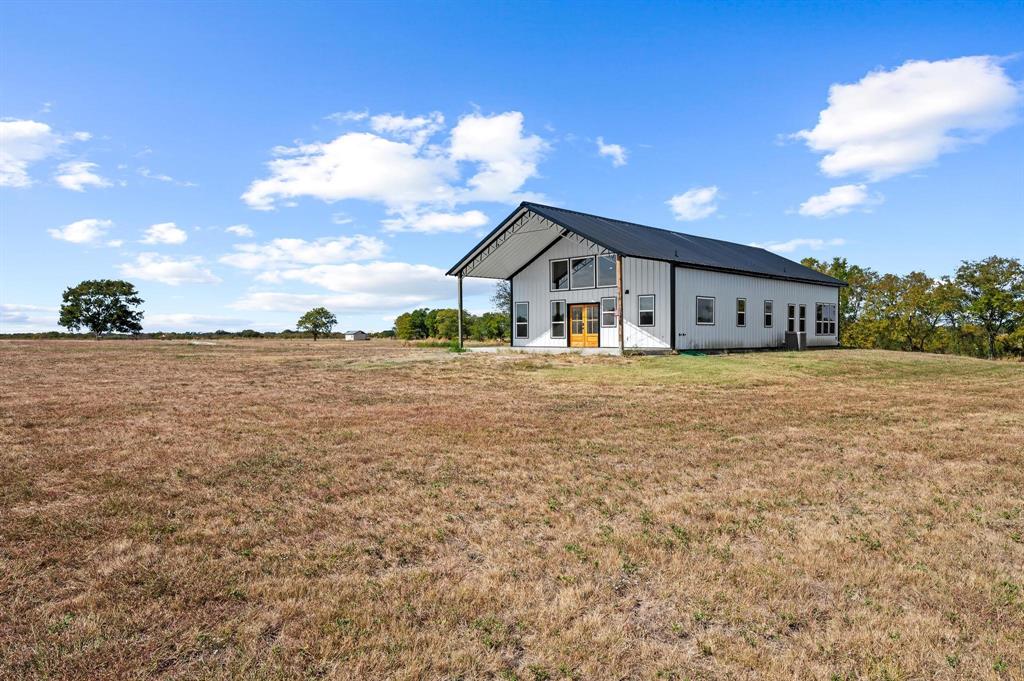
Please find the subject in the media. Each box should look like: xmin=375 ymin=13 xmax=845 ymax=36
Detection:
xmin=447 ymin=202 xmax=846 ymax=352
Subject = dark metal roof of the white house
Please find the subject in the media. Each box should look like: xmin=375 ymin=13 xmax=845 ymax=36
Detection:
xmin=450 ymin=202 xmax=846 ymax=286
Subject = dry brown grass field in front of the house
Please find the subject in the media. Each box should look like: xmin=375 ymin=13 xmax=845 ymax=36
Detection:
xmin=0 ymin=340 xmax=1024 ymax=679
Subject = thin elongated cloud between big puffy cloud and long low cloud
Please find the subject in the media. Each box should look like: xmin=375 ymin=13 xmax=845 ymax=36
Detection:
xmin=220 ymin=235 xmax=386 ymax=269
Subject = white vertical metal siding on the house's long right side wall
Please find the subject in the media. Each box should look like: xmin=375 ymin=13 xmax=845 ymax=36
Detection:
xmin=676 ymin=266 xmax=839 ymax=350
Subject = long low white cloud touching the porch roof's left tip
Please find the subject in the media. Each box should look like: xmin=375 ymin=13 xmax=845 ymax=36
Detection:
xmin=232 ymin=262 xmax=455 ymax=311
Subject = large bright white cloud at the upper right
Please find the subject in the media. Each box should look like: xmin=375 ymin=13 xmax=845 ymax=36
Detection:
xmin=795 ymin=56 xmax=1021 ymax=181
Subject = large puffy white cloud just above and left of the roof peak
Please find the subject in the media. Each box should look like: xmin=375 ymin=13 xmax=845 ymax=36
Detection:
xmin=242 ymin=112 xmax=547 ymax=215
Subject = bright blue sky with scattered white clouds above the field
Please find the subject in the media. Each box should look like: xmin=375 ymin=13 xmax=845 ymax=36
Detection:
xmin=0 ymin=2 xmax=1024 ymax=332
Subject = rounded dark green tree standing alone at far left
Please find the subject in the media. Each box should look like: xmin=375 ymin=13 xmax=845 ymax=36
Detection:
xmin=57 ymin=279 xmax=144 ymax=339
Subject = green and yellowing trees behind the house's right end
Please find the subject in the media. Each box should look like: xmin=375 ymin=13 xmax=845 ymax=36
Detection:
xmin=801 ymin=255 xmax=1024 ymax=357
